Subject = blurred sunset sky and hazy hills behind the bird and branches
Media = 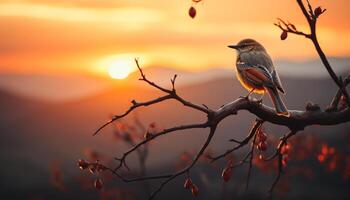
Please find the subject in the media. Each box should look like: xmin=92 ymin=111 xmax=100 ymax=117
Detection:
xmin=0 ymin=0 xmax=350 ymax=199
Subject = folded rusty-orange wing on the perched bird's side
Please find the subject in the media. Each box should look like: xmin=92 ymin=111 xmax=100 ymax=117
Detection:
xmin=237 ymin=62 xmax=276 ymax=88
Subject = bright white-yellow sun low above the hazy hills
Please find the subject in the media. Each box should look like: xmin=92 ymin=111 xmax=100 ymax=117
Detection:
xmin=108 ymin=58 xmax=135 ymax=79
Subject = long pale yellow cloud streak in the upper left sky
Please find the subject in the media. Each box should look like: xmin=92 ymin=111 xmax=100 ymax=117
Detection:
xmin=0 ymin=3 xmax=163 ymax=28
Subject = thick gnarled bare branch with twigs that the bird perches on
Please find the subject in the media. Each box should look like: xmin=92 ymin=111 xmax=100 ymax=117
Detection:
xmin=90 ymin=56 xmax=350 ymax=199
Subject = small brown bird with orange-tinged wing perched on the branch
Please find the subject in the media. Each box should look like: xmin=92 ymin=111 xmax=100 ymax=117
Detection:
xmin=228 ymin=39 xmax=289 ymax=116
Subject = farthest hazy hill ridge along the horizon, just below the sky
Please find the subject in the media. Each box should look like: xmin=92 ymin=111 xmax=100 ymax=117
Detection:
xmin=0 ymin=57 xmax=350 ymax=102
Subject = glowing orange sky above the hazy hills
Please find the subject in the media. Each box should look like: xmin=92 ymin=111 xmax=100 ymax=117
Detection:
xmin=0 ymin=0 xmax=350 ymax=77
